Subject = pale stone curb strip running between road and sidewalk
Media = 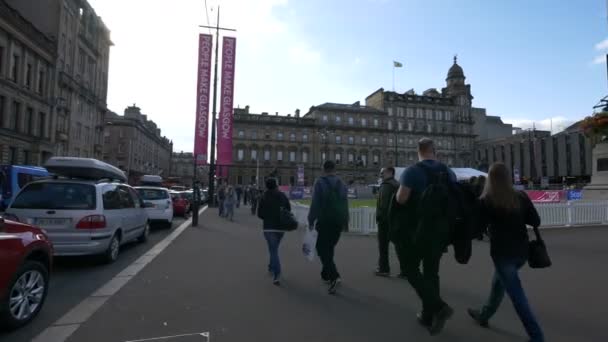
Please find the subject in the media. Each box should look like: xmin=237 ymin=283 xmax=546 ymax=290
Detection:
xmin=32 ymin=206 xmax=208 ymax=342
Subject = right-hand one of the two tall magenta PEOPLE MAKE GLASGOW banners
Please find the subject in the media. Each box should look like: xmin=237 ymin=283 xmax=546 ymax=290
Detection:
xmin=217 ymin=37 xmax=236 ymax=177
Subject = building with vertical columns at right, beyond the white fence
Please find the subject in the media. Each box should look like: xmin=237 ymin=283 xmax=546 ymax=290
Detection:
xmin=475 ymin=122 xmax=592 ymax=184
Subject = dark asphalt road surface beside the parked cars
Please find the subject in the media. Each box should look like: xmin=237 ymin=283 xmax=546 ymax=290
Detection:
xmin=0 ymin=218 xmax=184 ymax=342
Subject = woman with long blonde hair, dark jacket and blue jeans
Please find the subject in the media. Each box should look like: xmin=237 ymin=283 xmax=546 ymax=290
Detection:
xmin=468 ymin=163 xmax=544 ymax=342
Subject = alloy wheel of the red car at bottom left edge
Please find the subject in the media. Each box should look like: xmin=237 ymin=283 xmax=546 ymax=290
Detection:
xmin=0 ymin=261 xmax=49 ymax=330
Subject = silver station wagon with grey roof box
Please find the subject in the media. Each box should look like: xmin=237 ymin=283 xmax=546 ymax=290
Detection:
xmin=5 ymin=157 xmax=150 ymax=263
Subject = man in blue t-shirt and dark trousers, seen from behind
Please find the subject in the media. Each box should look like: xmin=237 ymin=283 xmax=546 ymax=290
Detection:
xmin=396 ymin=138 xmax=457 ymax=335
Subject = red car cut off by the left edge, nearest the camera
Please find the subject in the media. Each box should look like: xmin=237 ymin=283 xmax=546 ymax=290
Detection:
xmin=0 ymin=217 xmax=53 ymax=330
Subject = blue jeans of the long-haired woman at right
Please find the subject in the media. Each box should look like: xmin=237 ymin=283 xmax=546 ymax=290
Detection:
xmin=481 ymin=258 xmax=545 ymax=342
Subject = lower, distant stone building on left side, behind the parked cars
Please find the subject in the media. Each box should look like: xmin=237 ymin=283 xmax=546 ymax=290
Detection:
xmin=103 ymin=105 xmax=173 ymax=183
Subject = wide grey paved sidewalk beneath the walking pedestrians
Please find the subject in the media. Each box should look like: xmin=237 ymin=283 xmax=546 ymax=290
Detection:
xmin=61 ymin=207 xmax=608 ymax=342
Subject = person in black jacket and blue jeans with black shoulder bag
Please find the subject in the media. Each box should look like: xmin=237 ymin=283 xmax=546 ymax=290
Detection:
xmin=258 ymin=178 xmax=291 ymax=286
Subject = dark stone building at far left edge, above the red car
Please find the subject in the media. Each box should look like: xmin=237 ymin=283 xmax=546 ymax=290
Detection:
xmin=0 ymin=0 xmax=56 ymax=165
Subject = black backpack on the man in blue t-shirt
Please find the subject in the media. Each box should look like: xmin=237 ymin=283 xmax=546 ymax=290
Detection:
xmin=416 ymin=162 xmax=475 ymax=264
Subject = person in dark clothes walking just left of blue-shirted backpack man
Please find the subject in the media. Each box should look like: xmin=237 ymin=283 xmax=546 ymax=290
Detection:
xmin=376 ymin=167 xmax=399 ymax=277
